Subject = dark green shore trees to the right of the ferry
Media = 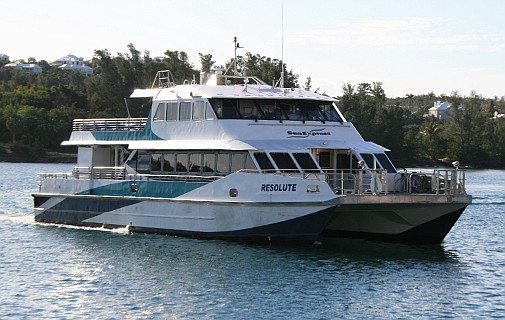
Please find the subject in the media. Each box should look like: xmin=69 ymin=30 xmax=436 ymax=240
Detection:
xmin=339 ymin=83 xmax=505 ymax=167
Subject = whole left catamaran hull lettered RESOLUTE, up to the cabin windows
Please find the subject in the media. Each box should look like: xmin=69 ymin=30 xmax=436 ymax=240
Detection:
xmin=34 ymin=173 xmax=333 ymax=241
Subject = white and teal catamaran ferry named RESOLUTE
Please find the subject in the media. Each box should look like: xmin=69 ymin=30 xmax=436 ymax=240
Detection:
xmin=33 ymin=66 xmax=471 ymax=243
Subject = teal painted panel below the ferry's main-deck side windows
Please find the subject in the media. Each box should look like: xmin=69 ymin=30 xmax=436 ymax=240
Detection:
xmin=79 ymin=180 xmax=208 ymax=198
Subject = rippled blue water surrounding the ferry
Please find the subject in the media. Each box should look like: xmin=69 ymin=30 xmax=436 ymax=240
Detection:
xmin=0 ymin=163 xmax=505 ymax=319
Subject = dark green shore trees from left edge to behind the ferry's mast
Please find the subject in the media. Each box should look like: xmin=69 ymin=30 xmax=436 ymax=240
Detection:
xmin=0 ymin=44 xmax=296 ymax=156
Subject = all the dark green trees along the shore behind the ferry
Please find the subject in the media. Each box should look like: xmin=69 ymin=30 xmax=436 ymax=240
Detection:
xmin=0 ymin=44 xmax=505 ymax=168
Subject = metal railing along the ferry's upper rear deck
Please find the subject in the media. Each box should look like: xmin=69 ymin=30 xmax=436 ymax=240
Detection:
xmin=72 ymin=118 xmax=147 ymax=131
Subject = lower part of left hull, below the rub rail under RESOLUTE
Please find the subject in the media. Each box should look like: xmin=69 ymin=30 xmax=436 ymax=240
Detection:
xmin=33 ymin=194 xmax=333 ymax=243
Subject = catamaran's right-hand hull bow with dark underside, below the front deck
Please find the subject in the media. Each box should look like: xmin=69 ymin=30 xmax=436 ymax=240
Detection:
xmin=322 ymin=195 xmax=471 ymax=244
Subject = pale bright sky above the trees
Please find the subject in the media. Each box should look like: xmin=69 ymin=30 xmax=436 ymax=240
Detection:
xmin=0 ymin=0 xmax=505 ymax=98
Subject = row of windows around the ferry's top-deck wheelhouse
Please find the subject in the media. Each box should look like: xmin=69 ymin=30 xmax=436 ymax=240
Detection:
xmin=154 ymin=99 xmax=343 ymax=122
